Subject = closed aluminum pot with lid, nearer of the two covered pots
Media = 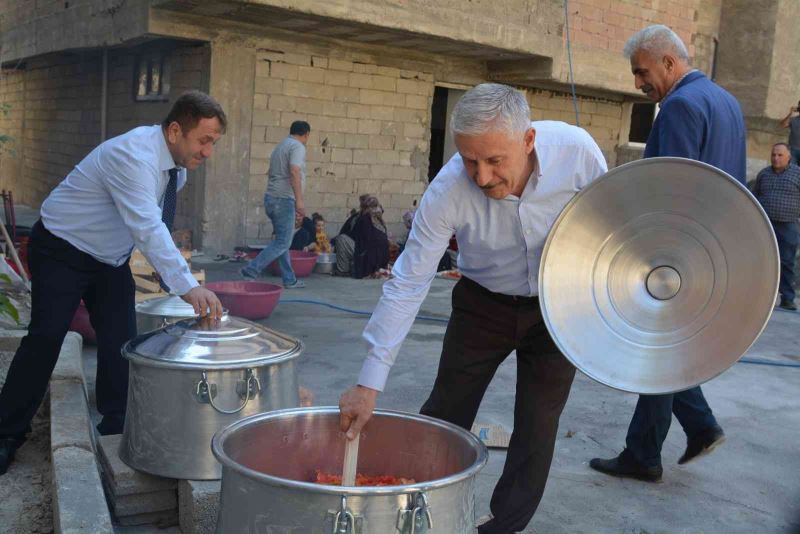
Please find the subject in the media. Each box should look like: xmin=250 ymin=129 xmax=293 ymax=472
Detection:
xmin=120 ymin=315 xmax=303 ymax=480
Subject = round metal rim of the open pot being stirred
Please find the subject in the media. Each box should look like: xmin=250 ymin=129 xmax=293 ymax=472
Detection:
xmin=211 ymin=406 xmax=489 ymax=496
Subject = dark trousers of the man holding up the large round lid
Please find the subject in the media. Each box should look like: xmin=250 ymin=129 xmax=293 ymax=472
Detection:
xmin=421 ymin=278 xmax=575 ymax=534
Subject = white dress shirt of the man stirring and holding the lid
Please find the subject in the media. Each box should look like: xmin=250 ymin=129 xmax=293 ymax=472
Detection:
xmin=358 ymin=121 xmax=608 ymax=390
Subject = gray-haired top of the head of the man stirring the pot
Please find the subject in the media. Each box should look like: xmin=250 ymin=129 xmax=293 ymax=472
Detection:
xmin=450 ymin=83 xmax=531 ymax=136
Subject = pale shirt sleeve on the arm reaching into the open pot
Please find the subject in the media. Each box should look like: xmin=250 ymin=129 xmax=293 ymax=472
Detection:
xmin=358 ymin=188 xmax=454 ymax=391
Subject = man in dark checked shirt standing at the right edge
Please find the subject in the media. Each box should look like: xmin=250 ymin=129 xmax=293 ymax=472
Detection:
xmin=753 ymin=143 xmax=800 ymax=311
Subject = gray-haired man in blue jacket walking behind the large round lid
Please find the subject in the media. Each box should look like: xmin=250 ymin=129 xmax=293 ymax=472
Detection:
xmin=589 ymin=25 xmax=746 ymax=482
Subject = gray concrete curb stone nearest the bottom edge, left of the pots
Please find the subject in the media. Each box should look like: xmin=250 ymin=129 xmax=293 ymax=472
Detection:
xmin=53 ymin=447 xmax=114 ymax=534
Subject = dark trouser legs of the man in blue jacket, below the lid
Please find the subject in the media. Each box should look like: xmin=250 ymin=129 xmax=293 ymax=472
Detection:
xmin=625 ymin=386 xmax=717 ymax=467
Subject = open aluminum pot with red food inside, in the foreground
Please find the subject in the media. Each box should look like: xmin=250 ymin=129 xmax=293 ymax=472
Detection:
xmin=212 ymin=407 xmax=488 ymax=534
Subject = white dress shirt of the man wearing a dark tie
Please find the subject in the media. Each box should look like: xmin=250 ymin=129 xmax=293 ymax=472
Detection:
xmin=41 ymin=125 xmax=198 ymax=295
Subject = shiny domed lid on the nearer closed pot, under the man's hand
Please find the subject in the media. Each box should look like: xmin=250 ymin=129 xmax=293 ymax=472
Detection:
xmin=122 ymin=315 xmax=303 ymax=370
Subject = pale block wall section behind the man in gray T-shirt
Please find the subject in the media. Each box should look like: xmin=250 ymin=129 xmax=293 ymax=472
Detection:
xmin=246 ymin=47 xmax=434 ymax=242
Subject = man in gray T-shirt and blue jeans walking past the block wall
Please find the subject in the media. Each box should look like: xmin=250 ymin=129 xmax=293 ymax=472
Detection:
xmin=241 ymin=121 xmax=311 ymax=289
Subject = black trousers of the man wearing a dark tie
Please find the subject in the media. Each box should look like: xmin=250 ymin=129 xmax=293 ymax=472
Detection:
xmin=0 ymin=221 xmax=136 ymax=438
